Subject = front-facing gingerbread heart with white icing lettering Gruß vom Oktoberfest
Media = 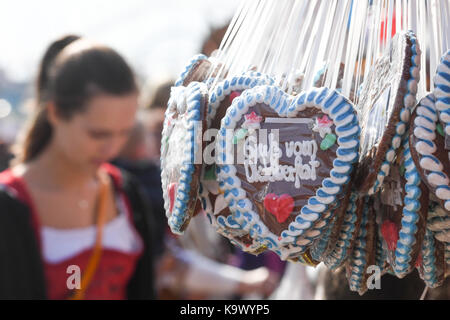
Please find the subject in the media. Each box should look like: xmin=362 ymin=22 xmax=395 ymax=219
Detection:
xmin=216 ymin=86 xmax=360 ymax=253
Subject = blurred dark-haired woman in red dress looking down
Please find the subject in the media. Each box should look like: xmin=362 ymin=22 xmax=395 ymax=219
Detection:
xmin=0 ymin=36 xmax=155 ymax=299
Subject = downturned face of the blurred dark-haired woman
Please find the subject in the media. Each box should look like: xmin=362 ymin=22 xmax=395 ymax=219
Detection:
xmin=51 ymin=93 xmax=138 ymax=171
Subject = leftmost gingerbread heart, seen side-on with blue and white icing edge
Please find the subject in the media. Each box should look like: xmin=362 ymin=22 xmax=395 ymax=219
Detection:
xmin=161 ymin=82 xmax=208 ymax=234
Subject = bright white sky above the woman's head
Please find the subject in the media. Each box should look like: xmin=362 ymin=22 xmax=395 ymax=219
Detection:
xmin=0 ymin=0 xmax=240 ymax=81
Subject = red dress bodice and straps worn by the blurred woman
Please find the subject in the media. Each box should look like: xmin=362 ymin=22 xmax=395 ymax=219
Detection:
xmin=0 ymin=164 xmax=143 ymax=300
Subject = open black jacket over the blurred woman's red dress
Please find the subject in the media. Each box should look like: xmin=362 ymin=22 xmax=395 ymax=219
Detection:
xmin=0 ymin=165 xmax=156 ymax=299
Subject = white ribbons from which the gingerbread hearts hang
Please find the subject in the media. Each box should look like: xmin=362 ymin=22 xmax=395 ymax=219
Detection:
xmin=208 ymin=0 xmax=450 ymax=103
